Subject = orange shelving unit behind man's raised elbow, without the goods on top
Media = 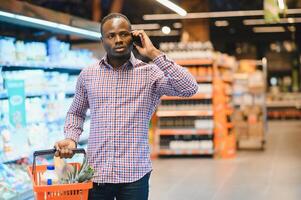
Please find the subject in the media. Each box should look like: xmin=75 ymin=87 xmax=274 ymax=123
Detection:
xmin=154 ymin=45 xmax=236 ymax=157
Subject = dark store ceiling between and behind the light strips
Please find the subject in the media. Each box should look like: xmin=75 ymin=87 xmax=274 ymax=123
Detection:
xmin=2 ymin=0 xmax=301 ymax=54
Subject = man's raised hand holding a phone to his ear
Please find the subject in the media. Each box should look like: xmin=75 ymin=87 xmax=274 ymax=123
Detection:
xmin=132 ymin=30 xmax=161 ymax=60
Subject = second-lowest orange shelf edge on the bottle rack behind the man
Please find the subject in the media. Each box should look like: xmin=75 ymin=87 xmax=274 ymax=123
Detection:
xmin=158 ymin=129 xmax=213 ymax=135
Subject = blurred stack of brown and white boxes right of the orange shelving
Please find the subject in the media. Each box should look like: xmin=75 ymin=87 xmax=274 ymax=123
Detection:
xmin=232 ymin=60 xmax=266 ymax=148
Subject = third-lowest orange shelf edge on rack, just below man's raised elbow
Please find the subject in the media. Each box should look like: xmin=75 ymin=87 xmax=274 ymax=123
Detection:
xmin=157 ymin=110 xmax=213 ymax=117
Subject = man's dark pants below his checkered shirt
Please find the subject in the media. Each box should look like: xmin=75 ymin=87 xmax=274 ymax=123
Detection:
xmin=89 ymin=173 xmax=150 ymax=200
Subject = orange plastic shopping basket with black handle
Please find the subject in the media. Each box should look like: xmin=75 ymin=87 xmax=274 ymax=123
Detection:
xmin=28 ymin=149 xmax=93 ymax=200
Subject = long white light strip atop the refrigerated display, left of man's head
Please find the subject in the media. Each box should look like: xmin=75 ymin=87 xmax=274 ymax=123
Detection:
xmin=0 ymin=11 xmax=101 ymax=40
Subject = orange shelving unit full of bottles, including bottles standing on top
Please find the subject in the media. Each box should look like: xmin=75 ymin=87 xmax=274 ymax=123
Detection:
xmin=154 ymin=42 xmax=237 ymax=157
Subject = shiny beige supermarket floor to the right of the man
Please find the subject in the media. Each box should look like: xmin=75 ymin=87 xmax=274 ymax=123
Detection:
xmin=150 ymin=121 xmax=301 ymax=200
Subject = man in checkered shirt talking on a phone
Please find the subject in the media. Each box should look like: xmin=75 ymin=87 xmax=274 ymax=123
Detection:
xmin=55 ymin=13 xmax=198 ymax=200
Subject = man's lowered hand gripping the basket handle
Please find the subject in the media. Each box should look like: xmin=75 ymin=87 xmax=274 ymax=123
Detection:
xmin=54 ymin=139 xmax=76 ymax=158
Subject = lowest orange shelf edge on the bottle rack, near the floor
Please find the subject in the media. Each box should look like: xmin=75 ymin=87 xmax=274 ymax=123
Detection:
xmin=159 ymin=149 xmax=214 ymax=155
